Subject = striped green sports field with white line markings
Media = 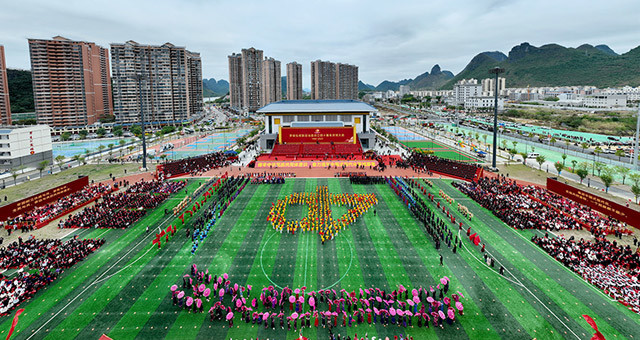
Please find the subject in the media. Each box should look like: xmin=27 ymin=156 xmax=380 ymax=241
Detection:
xmin=0 ymin=178 xmax=640 ymax=339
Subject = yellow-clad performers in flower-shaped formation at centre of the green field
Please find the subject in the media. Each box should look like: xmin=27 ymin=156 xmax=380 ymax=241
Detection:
xmin=267 ymin=186 xmax=378 ymax=242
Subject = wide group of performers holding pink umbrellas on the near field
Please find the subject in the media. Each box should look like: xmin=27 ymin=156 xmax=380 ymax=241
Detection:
xmin=170 ymin=265 xmax=464 ymax=332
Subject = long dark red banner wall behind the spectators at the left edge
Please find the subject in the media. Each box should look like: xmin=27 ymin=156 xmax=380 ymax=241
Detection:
xmin=0 ymin=176 xmax=89 ymax=221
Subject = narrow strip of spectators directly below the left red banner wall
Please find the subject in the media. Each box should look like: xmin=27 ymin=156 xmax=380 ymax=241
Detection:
xmin=0 ymin=184 xmax=111 ymax=229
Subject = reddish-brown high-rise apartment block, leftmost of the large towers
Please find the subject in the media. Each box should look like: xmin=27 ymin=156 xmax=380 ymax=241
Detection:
xmin=29 ymin=36 xmax=113 ymax=127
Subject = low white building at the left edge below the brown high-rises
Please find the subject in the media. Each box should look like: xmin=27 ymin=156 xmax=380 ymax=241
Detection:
xmin=0 ymin=125 xmax=53 ymax=170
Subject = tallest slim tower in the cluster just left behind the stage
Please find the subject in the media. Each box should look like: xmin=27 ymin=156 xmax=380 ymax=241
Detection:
xmin=242 ymin=47 xmax=263 ymax=112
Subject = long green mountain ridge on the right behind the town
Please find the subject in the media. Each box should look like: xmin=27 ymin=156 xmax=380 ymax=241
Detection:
xmin=442 ymin=42 xmax=640 ymax=89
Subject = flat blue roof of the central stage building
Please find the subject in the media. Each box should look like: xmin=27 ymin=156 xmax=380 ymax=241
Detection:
xmin=256 ymin=100 xmax=378 ymax=113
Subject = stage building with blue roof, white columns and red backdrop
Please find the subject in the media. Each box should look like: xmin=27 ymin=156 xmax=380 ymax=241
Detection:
xmin=257 ymin=100 xmax=377 ymax=151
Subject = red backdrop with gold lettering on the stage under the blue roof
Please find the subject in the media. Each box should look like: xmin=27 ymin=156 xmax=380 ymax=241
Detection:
xmin=280 ymin=127 xmax=356 ymax=144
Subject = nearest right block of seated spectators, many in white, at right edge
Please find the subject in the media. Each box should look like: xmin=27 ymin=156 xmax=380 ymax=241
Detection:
xmin=531 ymin=235 xmax=640 ymax=313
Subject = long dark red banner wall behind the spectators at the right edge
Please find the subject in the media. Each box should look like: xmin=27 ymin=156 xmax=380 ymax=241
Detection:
xmin=547 ymin=178 xmax=640 ymax=229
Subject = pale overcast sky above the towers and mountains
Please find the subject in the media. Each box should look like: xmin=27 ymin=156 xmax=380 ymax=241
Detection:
xmin=0 ymin=0 xmax=640 ymax=88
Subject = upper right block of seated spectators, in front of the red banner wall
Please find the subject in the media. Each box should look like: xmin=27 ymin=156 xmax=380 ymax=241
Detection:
xmin=454 ymin=177 xmax=582 ymax=230
